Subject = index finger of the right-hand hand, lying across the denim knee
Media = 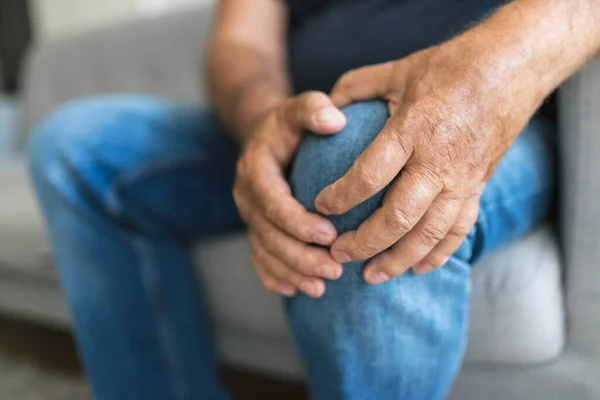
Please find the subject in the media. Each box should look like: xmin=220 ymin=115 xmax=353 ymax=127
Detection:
xmin=315 ymin=114 xmax=412 ymax=215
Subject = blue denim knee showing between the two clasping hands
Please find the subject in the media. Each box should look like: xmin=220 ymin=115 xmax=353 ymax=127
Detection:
xmin=290 ymin=101 xmax=389 ymax=233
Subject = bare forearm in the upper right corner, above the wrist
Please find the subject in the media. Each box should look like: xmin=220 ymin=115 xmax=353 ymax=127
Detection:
xmin=455 ymin=0 xmax=600 ymax=115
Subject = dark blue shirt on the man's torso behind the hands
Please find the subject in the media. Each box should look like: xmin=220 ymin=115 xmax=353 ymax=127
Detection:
xmin=284 ymin=0 xmax=503 ymax=92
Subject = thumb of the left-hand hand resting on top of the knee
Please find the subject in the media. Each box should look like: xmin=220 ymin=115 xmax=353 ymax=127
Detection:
xmin=283 ymin=91 xmax=346 ymax=134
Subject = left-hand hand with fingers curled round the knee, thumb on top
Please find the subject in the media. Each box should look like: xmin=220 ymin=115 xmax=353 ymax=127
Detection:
xmin=234 ymin=92 xmax=346 ymax=297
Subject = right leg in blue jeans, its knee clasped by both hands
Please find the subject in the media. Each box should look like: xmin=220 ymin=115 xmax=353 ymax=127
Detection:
xmin=287 ymin=102 xmax=552 ymax=400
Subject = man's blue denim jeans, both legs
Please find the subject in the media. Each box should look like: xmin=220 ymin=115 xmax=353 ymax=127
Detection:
xmin=29 ymin=96 xmax=553 ymax=400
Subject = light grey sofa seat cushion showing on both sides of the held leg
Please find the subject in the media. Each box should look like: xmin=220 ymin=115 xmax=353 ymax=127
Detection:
xmin=195 ymin=226 xmax=564 ymax=374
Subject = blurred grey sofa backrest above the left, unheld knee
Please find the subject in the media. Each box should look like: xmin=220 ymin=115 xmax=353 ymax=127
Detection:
xmin=19 ymin=6 xmax=213 ymax=148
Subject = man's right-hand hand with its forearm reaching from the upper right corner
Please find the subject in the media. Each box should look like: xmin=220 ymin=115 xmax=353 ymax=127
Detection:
xmin=315 ymin=0 xmax=600 ymax=284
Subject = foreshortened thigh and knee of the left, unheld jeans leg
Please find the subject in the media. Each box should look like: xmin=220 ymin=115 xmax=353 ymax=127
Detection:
xmin=30 ymin=96 xmax=241 ymax=236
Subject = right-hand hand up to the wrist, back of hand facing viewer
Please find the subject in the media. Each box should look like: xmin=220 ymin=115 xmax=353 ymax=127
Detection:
xmin=315 ymin=39 xmax=541 ymax=284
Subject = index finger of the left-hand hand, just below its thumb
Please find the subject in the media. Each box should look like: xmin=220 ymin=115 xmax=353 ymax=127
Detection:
xmin=243 ymin=155 xmax=337 ymax=246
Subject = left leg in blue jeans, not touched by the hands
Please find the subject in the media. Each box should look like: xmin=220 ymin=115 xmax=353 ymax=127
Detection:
xmin=29 ymin=97 xmax=241 ymax=400
